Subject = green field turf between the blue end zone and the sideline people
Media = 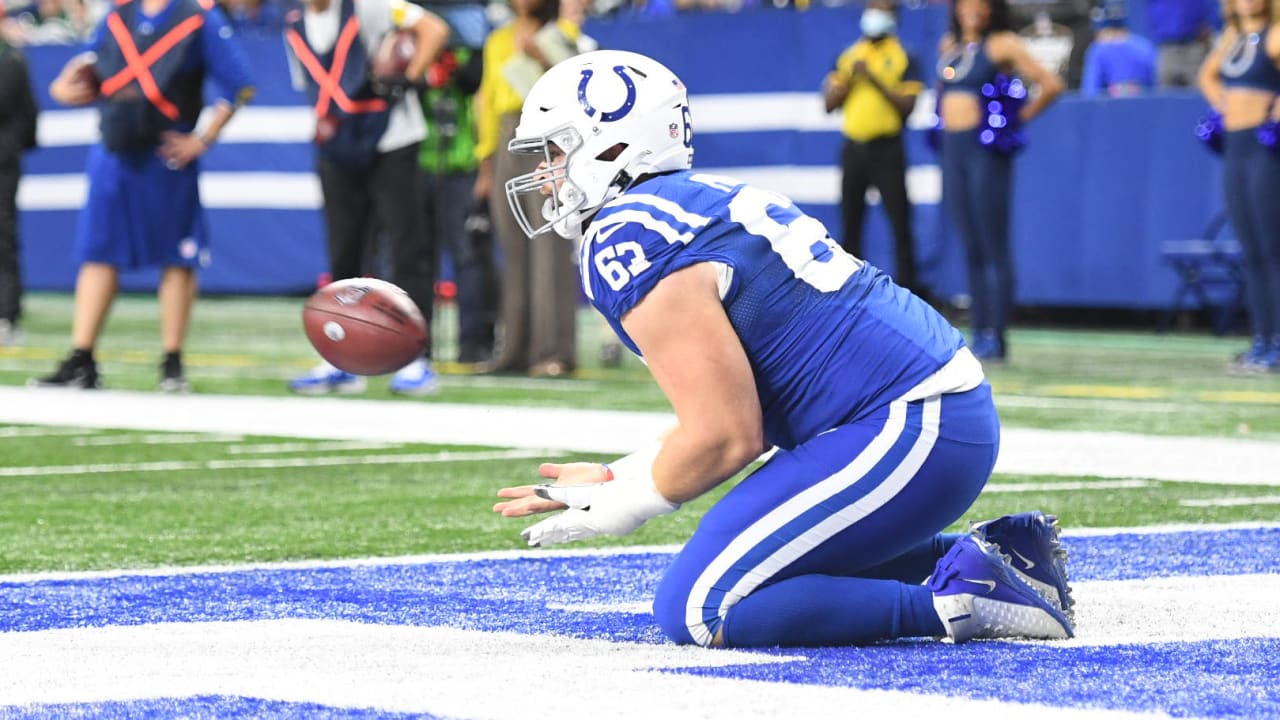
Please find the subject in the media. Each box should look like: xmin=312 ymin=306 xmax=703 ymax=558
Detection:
xmin=0 ymin=295 xmax=1280 ymax=573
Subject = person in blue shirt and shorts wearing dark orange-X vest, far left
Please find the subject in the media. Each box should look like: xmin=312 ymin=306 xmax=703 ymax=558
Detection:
xmin=31 ymin=0 xmax=253 ymax=392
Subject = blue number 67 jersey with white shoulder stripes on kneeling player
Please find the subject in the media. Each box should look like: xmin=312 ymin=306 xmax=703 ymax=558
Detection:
xmin=581 ymin=170 xmax=964 ymax=448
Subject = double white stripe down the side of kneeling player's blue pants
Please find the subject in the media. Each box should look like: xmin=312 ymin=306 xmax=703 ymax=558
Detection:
xmin=685 ymin=401 xmax=937 ymax=646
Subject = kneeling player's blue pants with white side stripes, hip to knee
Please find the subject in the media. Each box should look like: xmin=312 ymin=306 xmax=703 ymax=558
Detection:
xmin=654 ymin=384 xmax=998 ymax=644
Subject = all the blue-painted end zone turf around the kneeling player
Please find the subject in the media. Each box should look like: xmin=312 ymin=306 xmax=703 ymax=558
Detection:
xmin=0 ymin=528 xmax=1280 ymax=717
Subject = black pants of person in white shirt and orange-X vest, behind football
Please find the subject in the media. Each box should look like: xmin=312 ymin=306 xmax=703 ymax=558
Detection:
xmin=319 ymin=142 xmax=435 ymax=357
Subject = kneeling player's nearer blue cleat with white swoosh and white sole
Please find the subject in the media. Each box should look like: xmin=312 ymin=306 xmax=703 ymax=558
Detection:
xmin=928 ymin=536 xmax=1074 ymax=643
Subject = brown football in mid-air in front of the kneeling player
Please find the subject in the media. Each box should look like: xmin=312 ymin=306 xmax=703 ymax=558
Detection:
xmin=302 ymin=278 xmax=428 ymax=375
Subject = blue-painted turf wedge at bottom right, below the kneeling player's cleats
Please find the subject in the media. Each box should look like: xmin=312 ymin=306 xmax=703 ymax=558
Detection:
xmin=678 ymin=638 xmax=1280 ymax=717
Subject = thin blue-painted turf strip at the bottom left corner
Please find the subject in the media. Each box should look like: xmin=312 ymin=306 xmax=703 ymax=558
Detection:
xmin=0 ymin=696 xmax=445 ymax=720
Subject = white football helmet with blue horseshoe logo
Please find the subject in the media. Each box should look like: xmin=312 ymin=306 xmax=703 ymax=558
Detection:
xmin=506 ymin=50 xmax=694 ymax=238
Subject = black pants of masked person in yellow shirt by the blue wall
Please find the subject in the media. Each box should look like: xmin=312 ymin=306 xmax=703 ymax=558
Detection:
xmin=840 ymin=135 xmax=923 ymax=295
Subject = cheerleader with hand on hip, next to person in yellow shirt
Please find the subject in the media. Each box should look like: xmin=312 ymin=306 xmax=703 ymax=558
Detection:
xmin=937 ymin=0 xmax=1062 ymax=361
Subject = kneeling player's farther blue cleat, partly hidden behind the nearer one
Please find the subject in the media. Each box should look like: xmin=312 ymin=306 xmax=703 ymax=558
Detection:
xmin=969 ymin=510 xmax=1075 ymax=619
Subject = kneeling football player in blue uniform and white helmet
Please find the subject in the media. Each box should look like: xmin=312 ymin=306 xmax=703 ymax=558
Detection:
xmin=494 ymin=51 xmax=1073 ymax=647
